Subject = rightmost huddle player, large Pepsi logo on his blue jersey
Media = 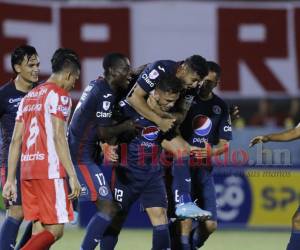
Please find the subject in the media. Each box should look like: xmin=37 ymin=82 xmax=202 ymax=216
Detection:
xmin=171 ymin=62 xmax=232 ymax=250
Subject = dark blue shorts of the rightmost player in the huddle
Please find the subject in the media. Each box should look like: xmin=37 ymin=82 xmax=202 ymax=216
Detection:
xmin=191 ymin=167 xmax=217 ymax=221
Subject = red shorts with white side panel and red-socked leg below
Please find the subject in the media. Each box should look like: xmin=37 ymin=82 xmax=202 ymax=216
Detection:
xmin=22 ymin=179 xmax=73 ymax=250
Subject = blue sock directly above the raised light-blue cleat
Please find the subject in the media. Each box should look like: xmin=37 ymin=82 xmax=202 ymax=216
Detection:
xmin=173 ymin=156 xmax=191 ymax=203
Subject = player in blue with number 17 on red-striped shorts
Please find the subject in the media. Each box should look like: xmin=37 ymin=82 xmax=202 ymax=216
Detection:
xmin=68 ymin=53 xmax=136 ymax=250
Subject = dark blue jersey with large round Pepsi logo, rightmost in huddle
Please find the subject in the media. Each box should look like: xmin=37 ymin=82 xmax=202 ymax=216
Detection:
xmin=180 ymin=94 xmax=232 ymax=147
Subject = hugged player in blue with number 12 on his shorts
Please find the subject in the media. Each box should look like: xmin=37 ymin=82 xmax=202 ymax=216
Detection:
xmin=101 ymin=74 xmax=182 ymax=250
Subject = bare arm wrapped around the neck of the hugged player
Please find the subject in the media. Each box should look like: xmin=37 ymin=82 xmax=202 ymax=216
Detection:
xmin=127 ymin=84 xmax=176 ymax=132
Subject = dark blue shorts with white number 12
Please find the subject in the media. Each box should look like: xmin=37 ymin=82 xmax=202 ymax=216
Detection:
xmin=112 ymin=167 xmax=168 ymax=212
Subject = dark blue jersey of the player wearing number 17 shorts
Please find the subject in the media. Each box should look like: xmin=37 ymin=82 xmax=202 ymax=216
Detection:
xmin=68 ymin=78 xmax=116 ymax=163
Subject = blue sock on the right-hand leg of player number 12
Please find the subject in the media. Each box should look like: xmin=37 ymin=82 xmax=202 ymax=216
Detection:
xmin=152 ymin=224 xmax=171 ymax=250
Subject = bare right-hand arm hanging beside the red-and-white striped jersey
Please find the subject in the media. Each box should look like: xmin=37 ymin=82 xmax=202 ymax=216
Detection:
xmin=51 ymin=116 xmax=81 ymax=199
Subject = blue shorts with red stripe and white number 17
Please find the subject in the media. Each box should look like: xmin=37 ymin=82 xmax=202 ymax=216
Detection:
xmin=75 ymin=162 xmax=113 ymax=201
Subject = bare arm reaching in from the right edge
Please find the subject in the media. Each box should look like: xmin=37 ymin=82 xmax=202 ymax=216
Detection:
xmin=249 ymin=125 xmax=300 ymax=147
